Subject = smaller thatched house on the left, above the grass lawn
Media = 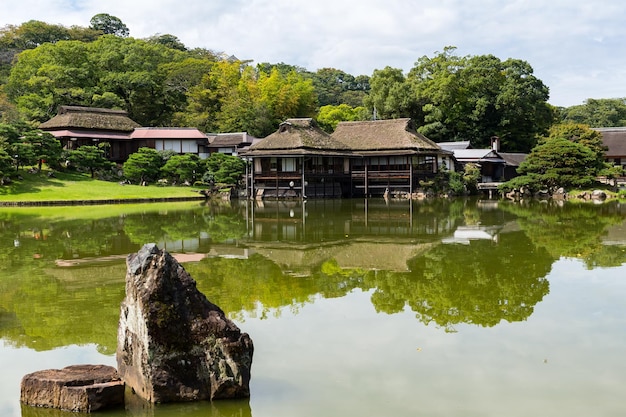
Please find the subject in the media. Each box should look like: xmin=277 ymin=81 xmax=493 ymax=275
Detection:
xmin=39 ymin=106 xmax=142 ymax=161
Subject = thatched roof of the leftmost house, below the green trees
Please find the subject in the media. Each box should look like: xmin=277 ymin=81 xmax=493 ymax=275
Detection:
xmin=39 ymin=106 xmax=140 ymax=132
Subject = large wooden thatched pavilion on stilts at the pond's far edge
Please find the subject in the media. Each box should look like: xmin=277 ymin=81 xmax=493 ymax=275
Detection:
xmin=242 ymin=118 xmax=454 ymax=198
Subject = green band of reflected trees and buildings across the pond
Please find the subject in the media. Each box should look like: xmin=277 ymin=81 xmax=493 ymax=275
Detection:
xmin=0 ymin=199 xmax=626 ymax=354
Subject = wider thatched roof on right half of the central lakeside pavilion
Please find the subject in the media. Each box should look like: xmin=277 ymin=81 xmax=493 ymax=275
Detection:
xmin=331 ymin=119 xmax=442 ymax=154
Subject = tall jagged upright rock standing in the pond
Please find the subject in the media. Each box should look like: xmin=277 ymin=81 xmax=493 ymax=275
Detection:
xmin=117 ymin=244 xmax=254 ymax=402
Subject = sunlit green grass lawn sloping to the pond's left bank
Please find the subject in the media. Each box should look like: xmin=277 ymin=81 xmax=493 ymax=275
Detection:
xmin=0 ymin=171 xmax=202 ymax=202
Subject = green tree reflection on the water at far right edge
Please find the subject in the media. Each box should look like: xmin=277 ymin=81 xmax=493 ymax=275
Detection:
xmin=502 ymin=202 xmax=626 ymax=268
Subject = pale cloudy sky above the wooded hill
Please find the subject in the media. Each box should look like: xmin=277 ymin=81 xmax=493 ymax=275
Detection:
xmin=0 ymin=0 xmax=626 ymax=107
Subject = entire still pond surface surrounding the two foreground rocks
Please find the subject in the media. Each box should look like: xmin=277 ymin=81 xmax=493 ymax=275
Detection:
xmin=0 ymin=200 xmax=626 ymax=417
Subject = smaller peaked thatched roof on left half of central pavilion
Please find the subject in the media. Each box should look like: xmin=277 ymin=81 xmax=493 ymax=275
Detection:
xmin=241 ymin=118 xmax=349 ymax=156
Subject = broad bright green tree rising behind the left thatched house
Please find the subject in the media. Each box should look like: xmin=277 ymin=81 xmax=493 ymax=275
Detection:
xmin=4 ymin=35 xmax=187 ymax=126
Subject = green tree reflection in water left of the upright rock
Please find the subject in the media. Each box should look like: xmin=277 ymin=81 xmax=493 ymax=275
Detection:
xmin=0 ymin=261 xmax=126 ymax=354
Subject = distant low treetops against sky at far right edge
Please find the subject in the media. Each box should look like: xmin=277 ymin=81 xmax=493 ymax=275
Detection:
xmin=561 ymin=98 xmax=626 ymax=127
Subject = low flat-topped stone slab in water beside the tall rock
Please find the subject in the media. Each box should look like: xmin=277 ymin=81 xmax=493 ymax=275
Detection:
xmin=20 ymin=365 xmax=124 ymax=413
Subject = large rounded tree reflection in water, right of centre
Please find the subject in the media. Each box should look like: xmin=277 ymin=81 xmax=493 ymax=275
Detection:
xmin=366 ymin=233 xmax=553 ymax=330
